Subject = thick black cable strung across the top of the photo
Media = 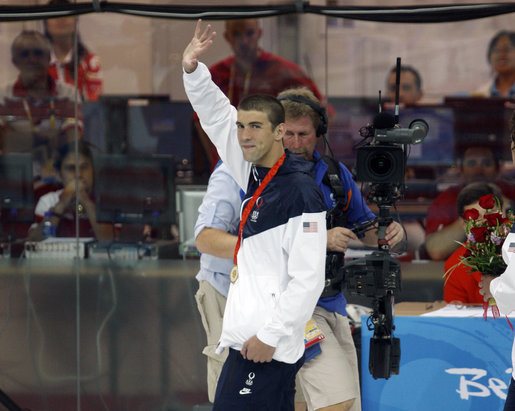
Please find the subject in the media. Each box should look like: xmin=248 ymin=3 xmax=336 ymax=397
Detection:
xmin=0 ymin=0 xmax=515 ymax=23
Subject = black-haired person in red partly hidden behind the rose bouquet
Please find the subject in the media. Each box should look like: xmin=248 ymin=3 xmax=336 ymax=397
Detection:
xmin=443 ymin=182 xmax=503 ymax=304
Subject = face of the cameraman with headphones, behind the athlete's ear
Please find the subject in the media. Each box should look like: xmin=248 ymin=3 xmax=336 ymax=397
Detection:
xmin=283 ymin=115 xmax=317 ymax=160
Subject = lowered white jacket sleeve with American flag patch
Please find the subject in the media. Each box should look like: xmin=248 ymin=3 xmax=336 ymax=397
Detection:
xmin=257 ymin=211 xmax=327 ymax=347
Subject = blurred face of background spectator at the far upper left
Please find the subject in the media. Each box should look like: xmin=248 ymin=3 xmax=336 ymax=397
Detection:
xmin=12 ymin=36 xmax=50 ymax=82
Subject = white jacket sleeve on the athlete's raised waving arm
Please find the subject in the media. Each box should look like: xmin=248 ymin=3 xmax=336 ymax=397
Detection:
xmin=183 ymin=62 xmax=251 ymax=190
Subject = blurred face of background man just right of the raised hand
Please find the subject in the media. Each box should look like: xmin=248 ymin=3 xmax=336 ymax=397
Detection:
xmin=224 ymin=20 xmax=263 ymax=61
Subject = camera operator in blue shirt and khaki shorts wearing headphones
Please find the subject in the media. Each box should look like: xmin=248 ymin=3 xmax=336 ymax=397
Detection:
xmin=278 ymin=88 xmax=404 ymax=410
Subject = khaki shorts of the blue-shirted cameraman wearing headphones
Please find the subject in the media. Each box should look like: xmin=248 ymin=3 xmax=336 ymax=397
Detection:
xmin=295 ymin=306 xmax=361 ymax=411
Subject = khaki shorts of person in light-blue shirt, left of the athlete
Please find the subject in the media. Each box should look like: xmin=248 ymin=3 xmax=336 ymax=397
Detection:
xmin=195 ymin=281 xmax=229 ymax=402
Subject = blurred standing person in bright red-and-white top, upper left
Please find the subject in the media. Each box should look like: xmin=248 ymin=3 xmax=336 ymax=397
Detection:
xmin=44 ymin=0 xmax=102 ymax=101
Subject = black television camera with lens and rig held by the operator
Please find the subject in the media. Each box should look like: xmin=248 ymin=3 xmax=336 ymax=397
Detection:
xmin=342 ymin=59 xmax=429 ymax=379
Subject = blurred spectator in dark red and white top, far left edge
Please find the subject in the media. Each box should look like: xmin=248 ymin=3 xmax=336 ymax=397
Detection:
xmin=0 ymin=31 xmax=81 ymax=180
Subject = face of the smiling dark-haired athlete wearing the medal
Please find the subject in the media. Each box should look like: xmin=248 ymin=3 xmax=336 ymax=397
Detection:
xmin=236 ymin=110 xmax=284 ymax=167
